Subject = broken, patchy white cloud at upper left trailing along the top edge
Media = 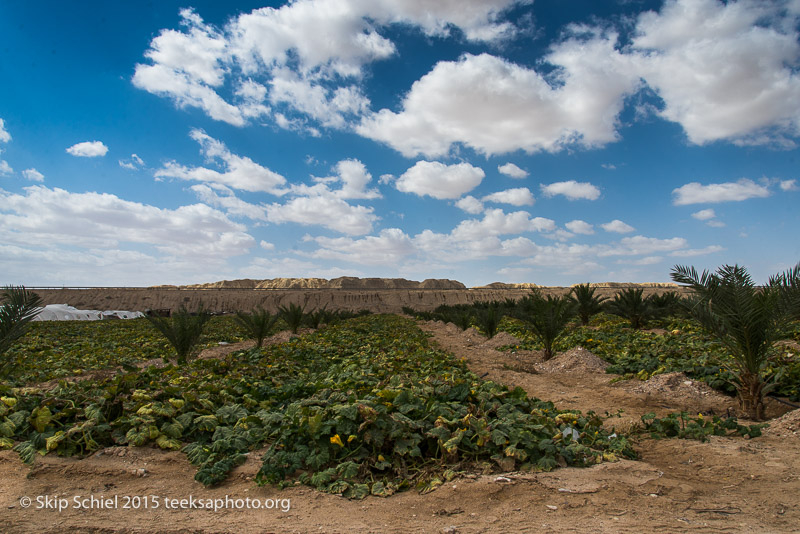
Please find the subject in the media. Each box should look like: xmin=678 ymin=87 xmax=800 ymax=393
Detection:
xmin=137 ymin=0 xmax=527 ymax=133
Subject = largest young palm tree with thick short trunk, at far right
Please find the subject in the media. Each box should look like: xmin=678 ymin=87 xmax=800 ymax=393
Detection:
xmin=671 ymin=264 xmax=800 ymax=420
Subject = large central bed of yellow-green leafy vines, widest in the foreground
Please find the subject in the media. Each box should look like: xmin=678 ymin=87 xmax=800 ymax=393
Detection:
xmin=0 ymin=316 xmax=634 ymax=497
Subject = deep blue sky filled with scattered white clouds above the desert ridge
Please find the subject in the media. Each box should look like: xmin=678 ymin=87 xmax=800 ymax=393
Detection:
xmin=0 ymin=0 xmax=800 ymax=286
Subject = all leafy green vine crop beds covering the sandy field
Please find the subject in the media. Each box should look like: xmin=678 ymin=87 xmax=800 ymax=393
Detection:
xmin=0 ymin=315 xmax=798 ymax=498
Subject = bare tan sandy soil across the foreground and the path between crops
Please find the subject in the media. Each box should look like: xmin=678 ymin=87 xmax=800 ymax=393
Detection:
xmin=0 ymin=323 xmax=800 ymax=534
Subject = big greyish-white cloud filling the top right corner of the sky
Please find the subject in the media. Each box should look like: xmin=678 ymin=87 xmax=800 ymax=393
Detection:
xmin=633 ymin=0 xmax=800 ymax=144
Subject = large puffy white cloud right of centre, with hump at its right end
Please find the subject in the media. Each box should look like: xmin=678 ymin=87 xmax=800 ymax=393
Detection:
xmin=356 ymin=44 xmax=639 ymax=157
